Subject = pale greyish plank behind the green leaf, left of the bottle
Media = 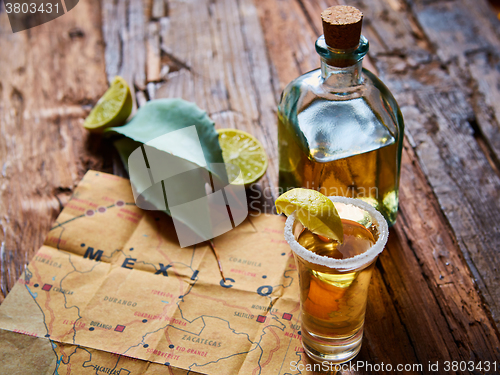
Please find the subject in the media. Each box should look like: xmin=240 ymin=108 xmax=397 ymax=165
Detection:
xmin=148 ymin=0 xmax=277 ymax=210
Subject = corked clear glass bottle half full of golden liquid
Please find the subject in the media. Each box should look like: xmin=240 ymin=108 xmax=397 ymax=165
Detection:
xmin=278 ymin=6 xmax=404 ymax=225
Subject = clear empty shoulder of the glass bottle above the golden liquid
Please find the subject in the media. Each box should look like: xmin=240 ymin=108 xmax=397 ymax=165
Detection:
xmin=278 ymin=69 xmax=404 ymax=161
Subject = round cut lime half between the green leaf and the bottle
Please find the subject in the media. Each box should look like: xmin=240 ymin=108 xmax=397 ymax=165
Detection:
xmin=217 ymin=129 xmax=267 ymax=185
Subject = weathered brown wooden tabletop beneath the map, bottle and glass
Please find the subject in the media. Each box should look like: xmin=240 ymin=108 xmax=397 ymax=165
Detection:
xmin=0 ymin=0 xmax=500 ymax=374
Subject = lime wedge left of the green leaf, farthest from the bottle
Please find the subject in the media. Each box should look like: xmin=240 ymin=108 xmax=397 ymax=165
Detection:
xmin=83 ymin=76 xmax=132 ymax=133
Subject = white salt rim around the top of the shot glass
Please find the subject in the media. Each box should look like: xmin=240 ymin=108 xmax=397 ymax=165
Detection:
xmin=285 ymin=197 xmax=389 ymax=269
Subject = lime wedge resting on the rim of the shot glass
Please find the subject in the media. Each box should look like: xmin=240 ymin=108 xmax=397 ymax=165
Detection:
xmin=275 ymin=189 xmax=344 ymax=243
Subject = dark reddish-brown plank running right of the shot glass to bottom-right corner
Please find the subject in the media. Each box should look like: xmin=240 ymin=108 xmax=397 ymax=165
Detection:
xmin=390 ymin=142 xmax=500 ymax=363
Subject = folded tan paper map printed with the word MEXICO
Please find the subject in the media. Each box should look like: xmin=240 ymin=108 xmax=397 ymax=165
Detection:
xmin=0 ymin=171 xmax=304 ymax=375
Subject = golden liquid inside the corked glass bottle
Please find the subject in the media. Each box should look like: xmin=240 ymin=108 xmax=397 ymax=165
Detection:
xmin=278 ymin=116 xmax=398 ymax=225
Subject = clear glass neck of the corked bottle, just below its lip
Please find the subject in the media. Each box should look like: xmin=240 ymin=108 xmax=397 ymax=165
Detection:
xmin=321 ymin=58 xmax=363 ymax=88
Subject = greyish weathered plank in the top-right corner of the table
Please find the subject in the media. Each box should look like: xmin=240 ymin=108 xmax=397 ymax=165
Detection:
xmin=413 ymin=0 xmax=500 ymax=167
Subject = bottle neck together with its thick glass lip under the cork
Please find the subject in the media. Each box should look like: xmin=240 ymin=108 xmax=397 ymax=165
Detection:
xmin=316 ymin=35 xmax=369 ymax=88
